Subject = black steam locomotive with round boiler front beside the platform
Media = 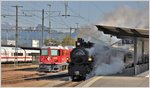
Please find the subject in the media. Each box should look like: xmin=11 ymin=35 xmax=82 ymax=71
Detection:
xmin=68 ymin=38 xmax=94 ymax=81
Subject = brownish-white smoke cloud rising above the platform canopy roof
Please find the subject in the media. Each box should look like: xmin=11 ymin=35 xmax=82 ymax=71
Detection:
xmin=98 ymin=6 xmax=149 ymax=29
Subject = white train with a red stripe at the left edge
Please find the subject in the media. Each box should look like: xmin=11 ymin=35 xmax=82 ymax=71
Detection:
xmin=0 ymin=47 xmax=40 ymax=63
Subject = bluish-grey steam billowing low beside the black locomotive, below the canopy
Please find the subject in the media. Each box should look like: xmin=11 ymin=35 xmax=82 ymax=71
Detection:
xmin=87 ymin=43 xmax=127 ymax=77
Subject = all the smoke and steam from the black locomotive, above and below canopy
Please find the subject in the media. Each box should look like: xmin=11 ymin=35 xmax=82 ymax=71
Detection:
xmin=78 ymin=6 xmax=149 ymax=77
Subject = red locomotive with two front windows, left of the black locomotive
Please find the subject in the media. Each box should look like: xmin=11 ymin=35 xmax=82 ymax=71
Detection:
xmin=39 ymin=46 xmax=72 ymax=72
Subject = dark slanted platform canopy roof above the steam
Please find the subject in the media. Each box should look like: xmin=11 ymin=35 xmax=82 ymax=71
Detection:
xmin=96 ymin=25 xmax=149 ymax=38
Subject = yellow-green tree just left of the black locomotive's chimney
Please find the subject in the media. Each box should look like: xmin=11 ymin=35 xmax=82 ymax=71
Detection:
xmin=62 ymin=35 xmax=75 ymax=46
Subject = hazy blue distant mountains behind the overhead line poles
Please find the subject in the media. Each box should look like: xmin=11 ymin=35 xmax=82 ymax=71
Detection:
xmin=1 ymin=22 xmax=76 ymax=46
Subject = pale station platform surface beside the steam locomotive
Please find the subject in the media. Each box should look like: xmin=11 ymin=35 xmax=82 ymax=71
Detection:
xmin=77 ymin=71 xmax=149 ymax=87
